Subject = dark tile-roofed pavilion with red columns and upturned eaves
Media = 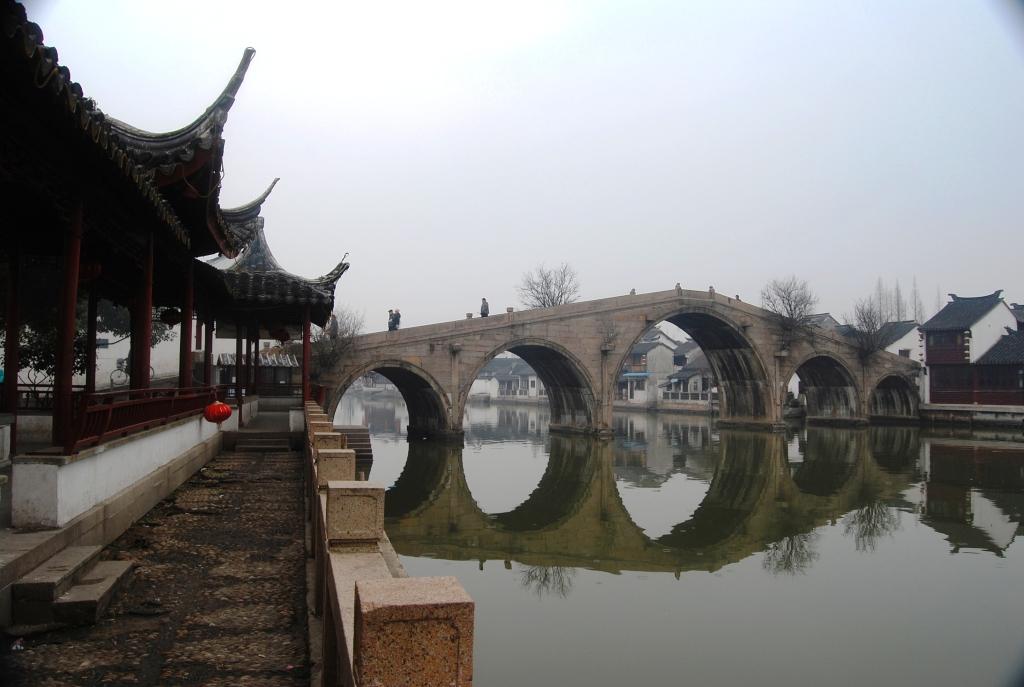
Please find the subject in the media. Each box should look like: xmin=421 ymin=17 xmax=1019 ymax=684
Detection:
xmin=0 ymin=0 xmax=348 ymax=526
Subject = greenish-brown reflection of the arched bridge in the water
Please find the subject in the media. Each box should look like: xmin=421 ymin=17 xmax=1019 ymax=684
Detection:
xmin=385 ymin=419 xmax=918 ymax=574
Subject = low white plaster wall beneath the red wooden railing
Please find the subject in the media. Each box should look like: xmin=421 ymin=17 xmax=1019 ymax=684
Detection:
xmin=11 ymin=415 xmax=238 ymax=527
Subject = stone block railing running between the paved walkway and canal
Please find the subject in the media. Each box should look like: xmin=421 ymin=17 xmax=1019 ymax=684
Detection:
xmin=304 ymin=401 xmax=474 ymax=687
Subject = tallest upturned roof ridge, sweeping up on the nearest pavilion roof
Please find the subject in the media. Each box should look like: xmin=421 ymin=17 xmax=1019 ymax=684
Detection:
xmin=106 ymin=47 xmax=256 ymax=166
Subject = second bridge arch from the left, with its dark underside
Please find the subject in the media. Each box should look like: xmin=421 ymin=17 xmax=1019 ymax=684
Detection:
xmin=458 ymin=337 xmax=597 ymax=428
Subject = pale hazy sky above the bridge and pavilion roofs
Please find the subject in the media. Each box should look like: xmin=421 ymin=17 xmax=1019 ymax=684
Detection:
xmin=28 ymin=0 xmax=1024 ymax=331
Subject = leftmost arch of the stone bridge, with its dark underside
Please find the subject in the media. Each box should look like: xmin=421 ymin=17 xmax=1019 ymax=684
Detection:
xmin=328 ymin=358 xmax=453 ymax=437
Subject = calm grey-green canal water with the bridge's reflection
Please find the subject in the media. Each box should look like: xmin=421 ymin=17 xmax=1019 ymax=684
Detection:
xmin=335 ymin=393 xmax=1024 ymax=687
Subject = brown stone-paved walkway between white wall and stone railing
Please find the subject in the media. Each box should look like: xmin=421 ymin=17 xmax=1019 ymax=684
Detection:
xmin=0 ymin=444 xmax=309 ymax=687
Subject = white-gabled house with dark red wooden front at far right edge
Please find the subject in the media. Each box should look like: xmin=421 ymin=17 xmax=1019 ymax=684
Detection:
xmin=920 ymin=290 xmax=1024 ymax=405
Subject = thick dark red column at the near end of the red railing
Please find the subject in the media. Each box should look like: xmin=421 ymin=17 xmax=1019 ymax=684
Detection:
xmin=52 ymin=200 xmax=84 ymax=446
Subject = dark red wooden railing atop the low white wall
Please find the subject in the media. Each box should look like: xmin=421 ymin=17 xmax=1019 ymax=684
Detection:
xmin=63 ymin=387 xmax=219 ymax=454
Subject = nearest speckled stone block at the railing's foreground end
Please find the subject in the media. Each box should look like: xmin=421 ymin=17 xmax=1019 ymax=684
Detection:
xmin=353 ymin=577 xmax=474 ymax=687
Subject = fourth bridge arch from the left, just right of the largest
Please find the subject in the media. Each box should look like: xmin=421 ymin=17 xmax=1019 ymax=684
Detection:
xmin=783 ymin=351 xmax=862 ymax=422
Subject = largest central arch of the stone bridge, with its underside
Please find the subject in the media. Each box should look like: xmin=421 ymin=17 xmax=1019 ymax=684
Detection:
xmin=611 ymin=306 xmax=773 ymax=421
